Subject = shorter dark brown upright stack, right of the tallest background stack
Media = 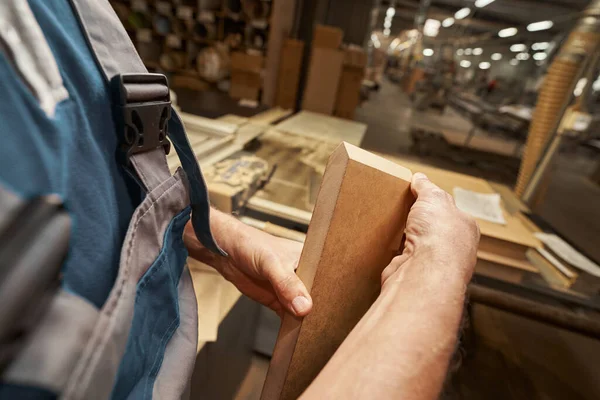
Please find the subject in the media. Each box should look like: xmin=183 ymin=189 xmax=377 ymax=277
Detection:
xmin=334 ymin=47 xmax=367 ymax=119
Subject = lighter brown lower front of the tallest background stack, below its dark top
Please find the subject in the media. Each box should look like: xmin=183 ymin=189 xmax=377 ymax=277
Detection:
xmin=302 ymin=48 xmax=344 ymax=115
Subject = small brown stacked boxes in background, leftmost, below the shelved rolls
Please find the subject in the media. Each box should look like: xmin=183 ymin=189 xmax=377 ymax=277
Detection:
xmin=229 ymin=52 xmax=264 ymax=101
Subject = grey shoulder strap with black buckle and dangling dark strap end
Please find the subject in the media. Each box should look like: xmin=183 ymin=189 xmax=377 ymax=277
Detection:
xmin=66 ymin=0 xmax=226 ymax=255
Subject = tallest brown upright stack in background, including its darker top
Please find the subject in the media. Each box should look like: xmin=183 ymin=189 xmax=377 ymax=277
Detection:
xmin=302 ymin=25 xmax=344 ymax=115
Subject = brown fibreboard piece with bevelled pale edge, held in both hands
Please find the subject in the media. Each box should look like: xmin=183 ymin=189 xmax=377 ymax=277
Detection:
xmin=261 ymin=143 xmax=414 ymax=400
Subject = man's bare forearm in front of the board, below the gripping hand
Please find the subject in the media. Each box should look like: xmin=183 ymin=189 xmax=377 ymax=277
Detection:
xmin=302 ymin=260 xmax=468 ymax=399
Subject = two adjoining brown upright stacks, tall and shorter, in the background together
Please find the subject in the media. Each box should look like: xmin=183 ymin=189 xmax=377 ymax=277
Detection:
xmin=302 ymin=25 xmax=367 ymax=119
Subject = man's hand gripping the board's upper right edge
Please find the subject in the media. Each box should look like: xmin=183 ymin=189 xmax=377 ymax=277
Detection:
xmin=382 ymin=173 xmax=479 ymax=287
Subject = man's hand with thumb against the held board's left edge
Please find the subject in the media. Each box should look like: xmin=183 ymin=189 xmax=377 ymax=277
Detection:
xmin=183 ymin=210 xmax=312 ymax=316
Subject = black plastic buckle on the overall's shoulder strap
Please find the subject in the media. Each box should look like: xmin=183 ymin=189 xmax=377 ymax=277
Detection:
xmin=115 ymin=73 xmax=171 ymax=166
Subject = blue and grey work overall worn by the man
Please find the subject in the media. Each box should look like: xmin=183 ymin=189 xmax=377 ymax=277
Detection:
xmin=0 ymin=0 xmax=224 ymax=399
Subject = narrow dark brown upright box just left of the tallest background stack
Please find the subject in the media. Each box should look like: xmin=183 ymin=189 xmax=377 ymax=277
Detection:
xmin=275 ymin=39 xmax=304 ymax=109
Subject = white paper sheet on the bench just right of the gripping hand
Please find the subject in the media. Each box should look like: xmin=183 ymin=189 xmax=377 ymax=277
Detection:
xmin=454 ymin=187 xmax=506 ymax=225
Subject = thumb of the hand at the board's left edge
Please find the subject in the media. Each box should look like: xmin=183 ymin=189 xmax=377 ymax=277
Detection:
xmin=266 ymin=266 xmax=312 ymax=317
